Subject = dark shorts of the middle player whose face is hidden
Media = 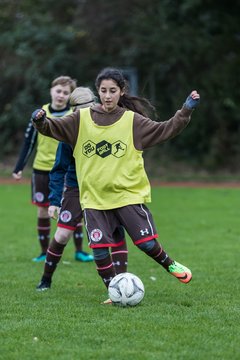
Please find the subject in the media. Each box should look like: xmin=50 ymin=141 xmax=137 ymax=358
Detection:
xmin=57 ymin=186 xmax=83 ymax=231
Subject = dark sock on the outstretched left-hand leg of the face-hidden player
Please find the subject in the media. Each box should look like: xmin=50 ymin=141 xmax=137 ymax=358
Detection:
xmin=43 ymin=238 xmax=66 ymax=281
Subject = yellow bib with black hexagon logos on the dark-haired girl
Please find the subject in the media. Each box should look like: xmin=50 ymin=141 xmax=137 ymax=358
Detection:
xmin=73 ymin=108 xmax=151 ymax=210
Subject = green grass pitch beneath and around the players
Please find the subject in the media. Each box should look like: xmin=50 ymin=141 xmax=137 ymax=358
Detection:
xmin=0 ymin=185 xmax=240 ymax=360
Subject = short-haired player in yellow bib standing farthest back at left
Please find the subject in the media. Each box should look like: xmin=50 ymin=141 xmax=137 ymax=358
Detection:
xmin=12 ymin=76 xmax=77 ymax=262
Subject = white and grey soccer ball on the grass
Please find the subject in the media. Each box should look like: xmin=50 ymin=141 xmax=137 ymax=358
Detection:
xmin=108 ymin=272 xmax=145 ymax=306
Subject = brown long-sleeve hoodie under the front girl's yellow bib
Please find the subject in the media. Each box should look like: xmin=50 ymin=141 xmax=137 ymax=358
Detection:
xmin=34 ymin=104 xmax=192 ymax=150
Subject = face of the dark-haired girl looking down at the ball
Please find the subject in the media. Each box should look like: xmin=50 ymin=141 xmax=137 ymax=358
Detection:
xmin=98 ymin=79 xmax=124 ymax=112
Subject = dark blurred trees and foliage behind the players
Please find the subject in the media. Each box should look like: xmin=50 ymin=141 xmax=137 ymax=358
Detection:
xmin=0 ymin=0 xmax=240 ymax=170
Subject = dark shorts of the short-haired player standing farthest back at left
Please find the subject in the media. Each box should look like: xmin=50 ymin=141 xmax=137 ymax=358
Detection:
xmin=31 ymin=169 xmax=49 ymax=207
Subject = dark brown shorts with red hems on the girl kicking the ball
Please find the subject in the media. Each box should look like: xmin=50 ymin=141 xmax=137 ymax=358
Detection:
xmin=84 ymin=204 xmax=158 ymax=248
